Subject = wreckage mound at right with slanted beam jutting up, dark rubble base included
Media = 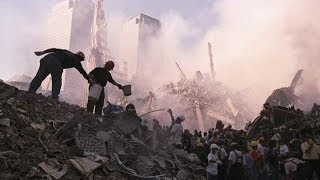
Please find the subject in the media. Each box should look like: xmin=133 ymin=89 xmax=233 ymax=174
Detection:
xmin=246 ymin=69 xmax=320 ymax=138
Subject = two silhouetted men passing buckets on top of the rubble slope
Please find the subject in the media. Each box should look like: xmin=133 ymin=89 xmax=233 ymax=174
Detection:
xmin=29 ymin=48 xmax=122 ymax=115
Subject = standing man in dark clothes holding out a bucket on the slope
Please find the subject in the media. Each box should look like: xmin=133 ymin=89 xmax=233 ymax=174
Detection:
xmin=87 ymin=61 xmax=122 ymax=115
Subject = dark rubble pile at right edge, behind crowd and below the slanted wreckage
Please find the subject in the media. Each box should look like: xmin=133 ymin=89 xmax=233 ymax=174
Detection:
xmin=246 ymin=103 xmax=320 ymax=139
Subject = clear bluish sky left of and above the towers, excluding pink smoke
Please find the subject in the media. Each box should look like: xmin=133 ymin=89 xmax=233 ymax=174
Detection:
xmin=0 ymin=0 xmax=212 ymax=80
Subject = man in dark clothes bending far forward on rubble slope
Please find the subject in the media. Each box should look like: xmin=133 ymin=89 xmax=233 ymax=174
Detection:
xmin=29 ymin=48 xmax=90 ymax=99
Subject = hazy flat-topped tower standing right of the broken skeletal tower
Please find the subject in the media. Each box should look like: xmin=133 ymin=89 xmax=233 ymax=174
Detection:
xmin=119 ymin=13 xmax=161 ymax=77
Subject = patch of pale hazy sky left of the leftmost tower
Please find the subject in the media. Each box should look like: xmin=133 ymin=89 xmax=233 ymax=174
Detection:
xmin=0 ymin=1 xmax=47 ymax=80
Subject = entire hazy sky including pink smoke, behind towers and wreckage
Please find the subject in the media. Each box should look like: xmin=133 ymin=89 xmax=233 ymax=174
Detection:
xmin=0 ymin=0 xmax=320 ymax=115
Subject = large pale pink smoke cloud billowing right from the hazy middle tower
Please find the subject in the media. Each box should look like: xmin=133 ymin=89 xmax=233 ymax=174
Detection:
xmin=108 ymin=0 xmax=320 ymax=118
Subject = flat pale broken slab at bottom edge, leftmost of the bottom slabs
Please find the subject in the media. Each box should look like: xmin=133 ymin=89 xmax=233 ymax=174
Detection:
xmin=38 ymin=159 xmax=68 ymax=179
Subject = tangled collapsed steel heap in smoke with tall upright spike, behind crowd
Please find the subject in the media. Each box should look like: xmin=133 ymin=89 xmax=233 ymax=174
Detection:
xmin=132 ymin=43 xmax=253 ymax=132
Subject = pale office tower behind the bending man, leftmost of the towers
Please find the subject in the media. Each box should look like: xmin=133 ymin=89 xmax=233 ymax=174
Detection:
xmin=45 ymin=0 xmax=94 ymax=104
